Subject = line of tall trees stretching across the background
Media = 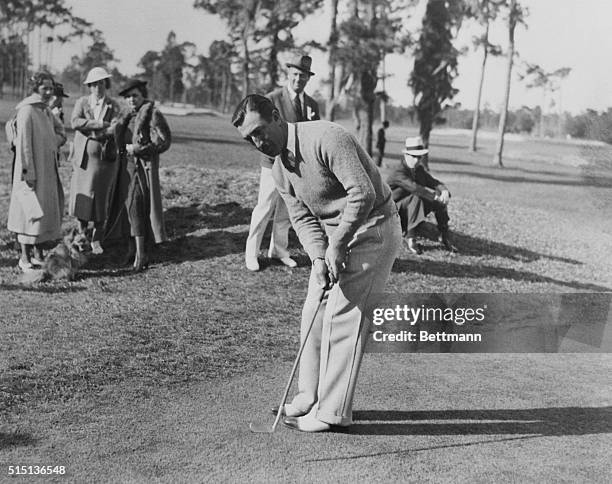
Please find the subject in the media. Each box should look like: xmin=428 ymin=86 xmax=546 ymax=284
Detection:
xmin=0 ymin=0 xmax=596 ymax=166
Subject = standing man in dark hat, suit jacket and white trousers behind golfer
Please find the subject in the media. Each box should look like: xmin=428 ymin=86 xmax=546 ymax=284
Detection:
xmin=245 ymin=55 xmax=319 ymax=271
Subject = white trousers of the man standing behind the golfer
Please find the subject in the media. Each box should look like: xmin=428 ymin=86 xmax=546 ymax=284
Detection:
xmin=244 ymin=166 xmax=291 ymax=259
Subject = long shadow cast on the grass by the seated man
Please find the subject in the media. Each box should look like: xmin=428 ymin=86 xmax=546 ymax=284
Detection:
xmin=418 ymin=222 xmax=584 ymax=265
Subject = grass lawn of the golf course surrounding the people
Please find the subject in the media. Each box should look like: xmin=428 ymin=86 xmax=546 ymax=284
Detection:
xmin=0 ymin=102 xmax=612 ymax=482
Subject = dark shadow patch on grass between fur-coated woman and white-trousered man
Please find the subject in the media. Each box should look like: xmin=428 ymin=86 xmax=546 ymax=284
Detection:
xmin=164 ymin=202 xmax=251 ymax=237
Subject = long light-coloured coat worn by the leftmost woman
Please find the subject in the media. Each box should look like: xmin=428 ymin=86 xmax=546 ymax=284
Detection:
xmin=7 ymin=94 xmax=64 ymax=244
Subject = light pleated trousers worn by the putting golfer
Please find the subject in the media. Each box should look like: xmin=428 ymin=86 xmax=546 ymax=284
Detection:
xmin=292 ymin=214 xmax=402 ymax=425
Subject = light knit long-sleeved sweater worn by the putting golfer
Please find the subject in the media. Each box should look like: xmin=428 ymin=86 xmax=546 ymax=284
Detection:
xmin=272 ymin=121 xmax=396 ymax=260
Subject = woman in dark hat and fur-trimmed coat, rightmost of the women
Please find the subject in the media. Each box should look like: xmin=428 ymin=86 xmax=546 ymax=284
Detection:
xmin=115 ymin=79 xmax=171 ymax=271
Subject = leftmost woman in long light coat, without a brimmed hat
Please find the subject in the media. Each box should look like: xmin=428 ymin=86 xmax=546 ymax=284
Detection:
xmin=7 ymin=72 xmax=64 ymax=272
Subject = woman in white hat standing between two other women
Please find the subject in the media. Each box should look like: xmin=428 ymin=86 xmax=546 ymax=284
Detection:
xmin=69 ymin=67 xmax=120 ymax=254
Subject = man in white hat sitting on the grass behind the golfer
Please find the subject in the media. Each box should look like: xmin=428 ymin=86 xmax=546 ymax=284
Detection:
xmin=387 ymin=136 xmax=457 ymax=254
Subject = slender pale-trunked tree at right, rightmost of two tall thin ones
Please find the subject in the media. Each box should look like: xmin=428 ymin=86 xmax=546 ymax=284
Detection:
xmin=468 ymin=0 xmax=503 ymax=151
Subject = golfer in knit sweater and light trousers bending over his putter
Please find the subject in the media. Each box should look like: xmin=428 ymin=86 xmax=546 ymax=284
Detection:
xmin=232 ymin=94 xmax=401 ymax=432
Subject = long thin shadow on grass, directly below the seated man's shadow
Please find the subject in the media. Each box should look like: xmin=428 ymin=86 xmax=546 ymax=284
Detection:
xmin=393 ymin=259 xmax=612 ymax=292
